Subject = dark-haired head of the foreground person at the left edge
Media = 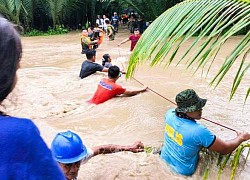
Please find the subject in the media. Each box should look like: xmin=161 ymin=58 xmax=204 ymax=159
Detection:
xmin=0 ymin=15 xmax=22 ymax=102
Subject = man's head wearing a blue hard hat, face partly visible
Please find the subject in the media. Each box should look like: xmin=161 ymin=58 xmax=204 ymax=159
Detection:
xmin=51 ymin=131 xmax=88 ymax=179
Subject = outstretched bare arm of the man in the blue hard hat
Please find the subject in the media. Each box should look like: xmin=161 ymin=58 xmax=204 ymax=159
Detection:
xmin=91 ymin=141 xmax=144 ymax=156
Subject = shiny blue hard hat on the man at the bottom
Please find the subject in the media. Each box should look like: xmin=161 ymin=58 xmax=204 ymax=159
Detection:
xmin=51 ymin=131 xmax=87 ymax=164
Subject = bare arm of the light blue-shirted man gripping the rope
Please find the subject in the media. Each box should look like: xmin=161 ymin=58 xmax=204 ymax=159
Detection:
xmin=209 ymin=133 xmax=250 ymax=154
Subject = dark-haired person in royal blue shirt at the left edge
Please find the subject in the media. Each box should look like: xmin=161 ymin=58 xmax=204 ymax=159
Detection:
xmin=0 ymin=16 xmax=65 ymax=180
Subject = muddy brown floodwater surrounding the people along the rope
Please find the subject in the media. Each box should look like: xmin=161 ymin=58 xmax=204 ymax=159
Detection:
xmin=5 ymin=28 xmax=250 ymax=180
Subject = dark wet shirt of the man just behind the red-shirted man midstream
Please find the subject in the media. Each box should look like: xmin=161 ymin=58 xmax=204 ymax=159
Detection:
xmin=79 ymin=60 xmax=104 ymax=78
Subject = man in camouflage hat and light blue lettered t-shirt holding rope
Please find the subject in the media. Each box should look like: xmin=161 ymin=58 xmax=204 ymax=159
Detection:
xmin=161 ymin=89 xmax=250 ymax=176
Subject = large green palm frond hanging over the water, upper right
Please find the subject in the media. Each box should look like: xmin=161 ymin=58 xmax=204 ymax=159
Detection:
xmin=127 ymin=0 xmax=250 ymax=99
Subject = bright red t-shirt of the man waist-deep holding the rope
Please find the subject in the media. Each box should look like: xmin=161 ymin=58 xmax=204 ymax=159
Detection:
xmin=89 ymin=79 xmax=126 ymax=104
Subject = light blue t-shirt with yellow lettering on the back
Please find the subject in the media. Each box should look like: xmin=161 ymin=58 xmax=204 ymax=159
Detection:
xmin=161 ymin=109 xmax=216 ymax=176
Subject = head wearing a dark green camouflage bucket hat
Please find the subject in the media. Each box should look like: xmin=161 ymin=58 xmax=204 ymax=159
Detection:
xmin=175 ymin=89 xmax=207 ymax=119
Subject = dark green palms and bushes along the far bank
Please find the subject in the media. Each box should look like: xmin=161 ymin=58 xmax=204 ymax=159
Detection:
xmin=0 ymin=0 xmax=180 ymax=35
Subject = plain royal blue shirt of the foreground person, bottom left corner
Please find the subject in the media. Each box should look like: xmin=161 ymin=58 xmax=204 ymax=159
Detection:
xmin=0 ymin=115 xmax=65 ymax=180
